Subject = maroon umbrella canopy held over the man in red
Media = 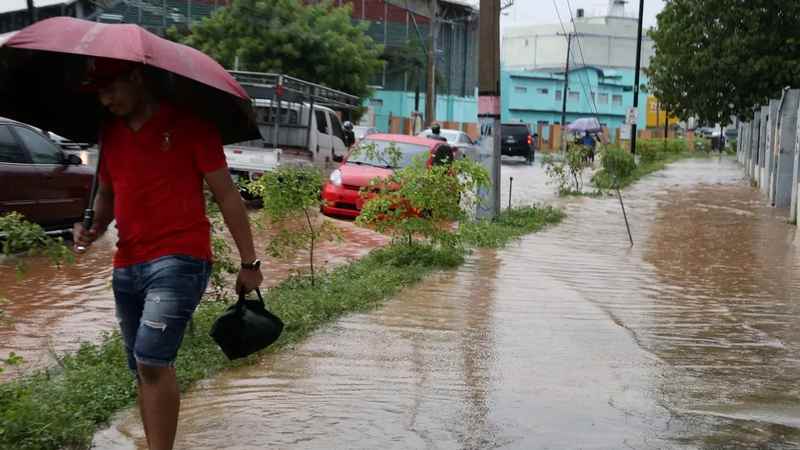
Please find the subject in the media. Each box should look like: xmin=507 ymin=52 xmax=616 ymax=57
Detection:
xmin=0 ymin=17 xmax=260 ymax=143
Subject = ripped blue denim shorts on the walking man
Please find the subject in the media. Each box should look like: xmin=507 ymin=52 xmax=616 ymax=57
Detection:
xmin=113 ymin=255 xmax=211 ymax=373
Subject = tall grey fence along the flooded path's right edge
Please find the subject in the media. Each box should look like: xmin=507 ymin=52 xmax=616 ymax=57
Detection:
xmin=736 ymin=88 xmax=800 ymax=224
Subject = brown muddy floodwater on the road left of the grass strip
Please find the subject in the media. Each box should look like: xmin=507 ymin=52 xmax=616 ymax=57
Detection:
xmin=0 ymin=216 xmax=386 ymax=381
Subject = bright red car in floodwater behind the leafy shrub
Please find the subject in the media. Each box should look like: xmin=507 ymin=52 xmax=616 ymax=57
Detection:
xmin=322 ymin=134 xmax=458 ymax=218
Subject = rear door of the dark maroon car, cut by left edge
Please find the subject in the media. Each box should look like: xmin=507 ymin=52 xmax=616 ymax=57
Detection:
xmin=0 ymin=124 xmax=44 ymax=223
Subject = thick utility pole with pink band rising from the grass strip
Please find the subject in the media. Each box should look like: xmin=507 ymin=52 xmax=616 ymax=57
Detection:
xmin=478 ymin=0 xmax=502 ymax=218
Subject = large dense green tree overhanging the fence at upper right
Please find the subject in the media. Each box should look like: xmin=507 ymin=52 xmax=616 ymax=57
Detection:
xmin=647 ymin=0 xmax=800 ymax=123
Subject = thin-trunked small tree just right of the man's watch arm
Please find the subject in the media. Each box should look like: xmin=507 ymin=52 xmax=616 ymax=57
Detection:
xmin=249 ymin=166 xmax=340 ymax=285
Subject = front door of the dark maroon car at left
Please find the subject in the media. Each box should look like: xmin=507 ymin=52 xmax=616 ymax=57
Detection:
xmin=11 ymin=125 xmax=91 ymax=226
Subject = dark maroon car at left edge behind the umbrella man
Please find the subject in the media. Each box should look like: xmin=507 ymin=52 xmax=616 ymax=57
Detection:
xmin=0 ymin=119 xmax=94 ymax=232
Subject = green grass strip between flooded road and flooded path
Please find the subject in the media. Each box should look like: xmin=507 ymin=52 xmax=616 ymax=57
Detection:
xmin=0 ymin=207 xmax=564 ymax=450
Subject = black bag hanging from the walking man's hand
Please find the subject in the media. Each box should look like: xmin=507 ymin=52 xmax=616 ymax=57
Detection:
xmin=209 ymin=289 xmax=283 ymax=359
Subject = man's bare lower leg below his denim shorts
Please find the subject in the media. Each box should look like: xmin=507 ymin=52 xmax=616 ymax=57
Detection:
xmin=139 ymin=364 xmax=180 ymax=450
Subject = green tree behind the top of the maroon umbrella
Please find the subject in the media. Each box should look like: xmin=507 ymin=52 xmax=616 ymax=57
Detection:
xmin=171 ymin=0 xmax=383 ymax=98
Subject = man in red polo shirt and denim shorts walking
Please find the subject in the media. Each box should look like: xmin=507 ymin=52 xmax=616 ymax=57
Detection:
xmin=73 ymin=58 xmax=263 ymax=450
